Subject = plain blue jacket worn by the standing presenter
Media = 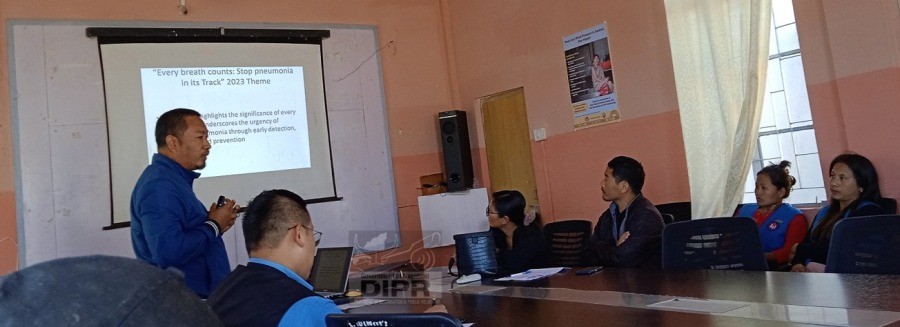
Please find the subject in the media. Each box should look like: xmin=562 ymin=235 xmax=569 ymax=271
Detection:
xmin=131 ymin=154 xmax=231 ymax=298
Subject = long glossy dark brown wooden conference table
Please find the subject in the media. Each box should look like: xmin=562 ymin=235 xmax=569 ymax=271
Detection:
xmin=349 ymin=268 xmax=900 ymax=326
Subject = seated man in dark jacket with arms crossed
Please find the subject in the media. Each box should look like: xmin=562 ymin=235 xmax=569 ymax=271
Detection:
xmin=586 ymin=156 xmax=663 ymax=268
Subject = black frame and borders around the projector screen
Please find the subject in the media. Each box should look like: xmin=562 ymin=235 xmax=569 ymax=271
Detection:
xmin=85 ymin=27 xmax=343 ymax=230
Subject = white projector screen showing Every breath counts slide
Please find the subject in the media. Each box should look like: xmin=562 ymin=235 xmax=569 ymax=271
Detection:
xmin=100 ymin=38 xmax=336 ymax=226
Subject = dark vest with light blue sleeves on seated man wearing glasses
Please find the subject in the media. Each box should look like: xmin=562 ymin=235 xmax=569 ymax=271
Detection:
xmin=207 ymin=258 xmax=341 ymax=327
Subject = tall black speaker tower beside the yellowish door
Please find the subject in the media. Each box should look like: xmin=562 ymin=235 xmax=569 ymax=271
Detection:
xmin=438 ymin=110 xmax=475 ymax=192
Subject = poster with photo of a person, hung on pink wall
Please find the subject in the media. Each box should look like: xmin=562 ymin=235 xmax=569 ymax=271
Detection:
xmin=563 ymin=22 xmax=619 ymax=130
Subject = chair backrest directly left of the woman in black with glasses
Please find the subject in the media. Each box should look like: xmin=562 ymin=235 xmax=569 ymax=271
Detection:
xmin=453 ymin=231 xmax=500 ymax=275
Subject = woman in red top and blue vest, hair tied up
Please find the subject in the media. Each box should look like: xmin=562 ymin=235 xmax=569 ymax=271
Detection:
xmin=736 ymin=160 xmax=807 ymax=270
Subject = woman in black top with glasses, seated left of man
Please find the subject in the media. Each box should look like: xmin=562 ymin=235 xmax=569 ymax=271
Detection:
xmin=485 ymin=190 xmax=548 ymax=275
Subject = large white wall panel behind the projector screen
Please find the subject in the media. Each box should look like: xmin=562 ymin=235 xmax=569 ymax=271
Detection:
xmin=8 ymin=21 xmax=399 ymax=267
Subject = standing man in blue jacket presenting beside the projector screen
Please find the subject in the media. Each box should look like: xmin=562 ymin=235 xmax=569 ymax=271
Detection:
xmin=131 ymin=108 xmax=240 ymax=298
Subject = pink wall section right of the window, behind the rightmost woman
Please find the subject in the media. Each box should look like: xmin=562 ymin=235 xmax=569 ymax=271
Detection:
xmin=794 ymin=0 xmax=900 ymax=198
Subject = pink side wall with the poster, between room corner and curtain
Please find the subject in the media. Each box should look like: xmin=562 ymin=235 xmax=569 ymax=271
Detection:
xmin=448 ymin=0 xmax=690 ymax=222
